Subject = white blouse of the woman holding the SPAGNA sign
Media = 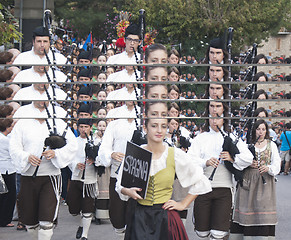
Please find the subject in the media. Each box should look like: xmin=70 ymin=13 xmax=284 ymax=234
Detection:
xmin=115 ymin=144 xmax=212 ymax=201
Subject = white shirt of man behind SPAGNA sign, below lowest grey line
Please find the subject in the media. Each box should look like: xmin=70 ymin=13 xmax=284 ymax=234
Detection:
xmin=98 ymin=119 xmax=136 ymax=178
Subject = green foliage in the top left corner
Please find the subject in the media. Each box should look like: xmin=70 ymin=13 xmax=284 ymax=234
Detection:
xmin=0 ymin=3 xmax=22 ymax=45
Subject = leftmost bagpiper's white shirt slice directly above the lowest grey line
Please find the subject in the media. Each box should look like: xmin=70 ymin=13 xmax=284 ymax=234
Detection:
xmin=13 ymin=103 xmax=67 ymax=119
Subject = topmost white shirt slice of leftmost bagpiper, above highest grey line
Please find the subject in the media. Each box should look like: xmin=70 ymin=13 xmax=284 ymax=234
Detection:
xmin=13 ymin=47 xmax=67 ymax=65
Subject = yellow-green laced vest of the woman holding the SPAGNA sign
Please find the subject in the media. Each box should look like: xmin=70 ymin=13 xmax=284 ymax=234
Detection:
xmin=138 ymin=147 xmax=175 ymax=206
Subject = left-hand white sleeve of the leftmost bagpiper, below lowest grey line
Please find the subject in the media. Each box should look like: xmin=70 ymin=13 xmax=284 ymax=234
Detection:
xmin=9 ymin=121 xmax=30 ymax=172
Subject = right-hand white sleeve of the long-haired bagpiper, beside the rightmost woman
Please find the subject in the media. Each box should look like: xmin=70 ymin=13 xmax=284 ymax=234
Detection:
xmin=233 ymin=139 xmax=254 ymax=170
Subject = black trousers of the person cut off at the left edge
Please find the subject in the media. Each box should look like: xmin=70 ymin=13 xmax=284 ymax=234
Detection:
xmin=0 ymin=173 xmax=16 ymax=227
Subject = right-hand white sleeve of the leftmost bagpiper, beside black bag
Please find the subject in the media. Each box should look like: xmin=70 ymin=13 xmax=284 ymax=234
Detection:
xmin=51 ymin=119 xmax=78 ymax=168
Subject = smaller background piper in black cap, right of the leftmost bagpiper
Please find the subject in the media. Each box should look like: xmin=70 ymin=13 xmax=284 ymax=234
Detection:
xmin=67 ymin=119 xmax=98 ymax=240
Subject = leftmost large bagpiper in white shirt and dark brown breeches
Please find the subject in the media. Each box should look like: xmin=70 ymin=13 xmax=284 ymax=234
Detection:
xmin=9 ymin=101 xmax=77 ymax=240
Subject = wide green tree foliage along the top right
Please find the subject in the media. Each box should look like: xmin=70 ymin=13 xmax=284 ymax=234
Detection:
xmin=123 ymin=0 xmax=291 ymax=50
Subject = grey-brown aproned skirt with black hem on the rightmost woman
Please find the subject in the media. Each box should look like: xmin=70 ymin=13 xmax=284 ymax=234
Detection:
xmin=229 ymin=168 xmax=277 ymax=240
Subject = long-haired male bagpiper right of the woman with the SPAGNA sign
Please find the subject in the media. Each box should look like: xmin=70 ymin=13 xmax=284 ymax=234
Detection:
xmin=187 ymin=102 xmax=253 ymax=240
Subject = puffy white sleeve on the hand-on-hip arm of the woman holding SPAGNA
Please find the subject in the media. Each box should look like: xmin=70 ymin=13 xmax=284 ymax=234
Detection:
xmin=174 ymin=148 xmax=212 ymax=195
